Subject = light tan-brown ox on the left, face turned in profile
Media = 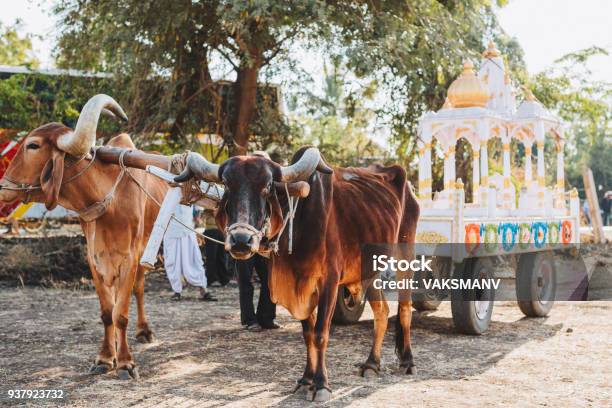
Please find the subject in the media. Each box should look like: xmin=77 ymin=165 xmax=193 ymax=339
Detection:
xmin=0 ymin=95 xmax=168 ymax=379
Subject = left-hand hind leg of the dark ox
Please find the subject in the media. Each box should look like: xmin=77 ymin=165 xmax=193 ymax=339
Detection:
xmin=359 ymin=286 xmax=389 ymax=377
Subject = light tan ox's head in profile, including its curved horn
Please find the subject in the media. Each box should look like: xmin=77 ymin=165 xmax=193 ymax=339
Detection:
xmin=0 ymin=95 xmax=127 ymax=210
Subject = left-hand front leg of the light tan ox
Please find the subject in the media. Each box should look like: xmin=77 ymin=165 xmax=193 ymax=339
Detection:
xmin=89 ymin=278 xmax=116 ymax=374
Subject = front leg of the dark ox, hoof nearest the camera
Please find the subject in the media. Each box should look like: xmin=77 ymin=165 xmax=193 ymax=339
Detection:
xmin=308 ymin=278 xmax=340 ymax=402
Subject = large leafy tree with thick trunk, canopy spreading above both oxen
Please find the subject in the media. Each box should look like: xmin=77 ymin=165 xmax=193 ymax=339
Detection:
xmin=55 ymin=0 xmax=504 ymax=158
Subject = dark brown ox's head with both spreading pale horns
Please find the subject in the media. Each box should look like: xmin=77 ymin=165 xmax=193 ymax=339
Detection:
xmin=175 ymin=147 xmax=332 ymax=259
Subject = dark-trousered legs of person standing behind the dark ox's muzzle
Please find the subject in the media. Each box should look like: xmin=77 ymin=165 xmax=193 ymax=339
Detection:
xmin=235 ymin=255 xmax=280 ymax=331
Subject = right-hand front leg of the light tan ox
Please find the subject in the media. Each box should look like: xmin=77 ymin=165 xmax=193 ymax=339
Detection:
xmin=113 ymin=265 xmax=139 ymax=380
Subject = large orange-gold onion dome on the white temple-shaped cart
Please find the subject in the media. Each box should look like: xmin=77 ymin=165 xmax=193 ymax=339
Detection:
xmin=448 ymin=60 xmax=490 ymax=108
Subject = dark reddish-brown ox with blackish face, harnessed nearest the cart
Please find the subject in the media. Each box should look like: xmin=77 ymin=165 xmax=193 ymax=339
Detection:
xmin=176 ymin=148 xmax=419 ymax=401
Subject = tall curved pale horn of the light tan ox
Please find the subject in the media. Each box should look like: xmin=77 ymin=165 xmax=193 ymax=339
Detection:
xmin=57 ymin=94 xmax=128 ymax=157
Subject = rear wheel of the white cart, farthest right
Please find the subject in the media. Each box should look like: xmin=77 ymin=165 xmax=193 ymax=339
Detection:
xmin=516 ymin=251 xmax=557 ymax=317
